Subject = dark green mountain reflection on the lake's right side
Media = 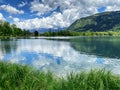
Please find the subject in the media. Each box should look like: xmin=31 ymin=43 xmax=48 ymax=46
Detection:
xmin=71 ymin=37 xmax=120 ymax=58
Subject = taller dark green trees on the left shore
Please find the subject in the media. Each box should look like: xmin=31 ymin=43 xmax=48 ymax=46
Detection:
xmin=0 ymin=20 xmax=31 ymax=37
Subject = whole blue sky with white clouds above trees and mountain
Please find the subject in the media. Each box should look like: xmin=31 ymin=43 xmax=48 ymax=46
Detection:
xmin=0 ymin=0 xmax=120 ymax=29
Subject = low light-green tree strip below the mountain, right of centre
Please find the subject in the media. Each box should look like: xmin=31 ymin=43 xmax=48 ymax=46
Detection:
xmin=40 ymin=30 xmax=120 ymax=36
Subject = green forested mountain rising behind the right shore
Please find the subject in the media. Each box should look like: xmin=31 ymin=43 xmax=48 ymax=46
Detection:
xmin=67 ymin=11 xmax=120 ymax=32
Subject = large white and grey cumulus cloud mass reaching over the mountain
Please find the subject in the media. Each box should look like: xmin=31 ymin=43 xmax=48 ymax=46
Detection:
xmin=16 ymin=0 xmax=120 ymax=29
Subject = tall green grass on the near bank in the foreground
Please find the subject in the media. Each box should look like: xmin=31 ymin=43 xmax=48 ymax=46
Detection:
xmin=0 ymin=62 xmax=120 ymax=90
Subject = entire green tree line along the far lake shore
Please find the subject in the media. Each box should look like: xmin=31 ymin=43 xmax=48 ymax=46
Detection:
xmin=0 ymin=20 xmax=120 ymax=36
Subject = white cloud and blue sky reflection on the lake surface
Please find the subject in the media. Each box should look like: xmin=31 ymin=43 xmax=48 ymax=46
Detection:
xmin=0 ymin=39 xmax=120 ymax=75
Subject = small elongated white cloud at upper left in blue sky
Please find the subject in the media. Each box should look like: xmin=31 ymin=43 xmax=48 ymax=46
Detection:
xmin=0 ymin=5 xmax=24 ymax=14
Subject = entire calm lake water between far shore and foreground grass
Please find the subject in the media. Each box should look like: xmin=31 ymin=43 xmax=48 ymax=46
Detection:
xmin=0 ymin=37 xmax=120 ymax=75
